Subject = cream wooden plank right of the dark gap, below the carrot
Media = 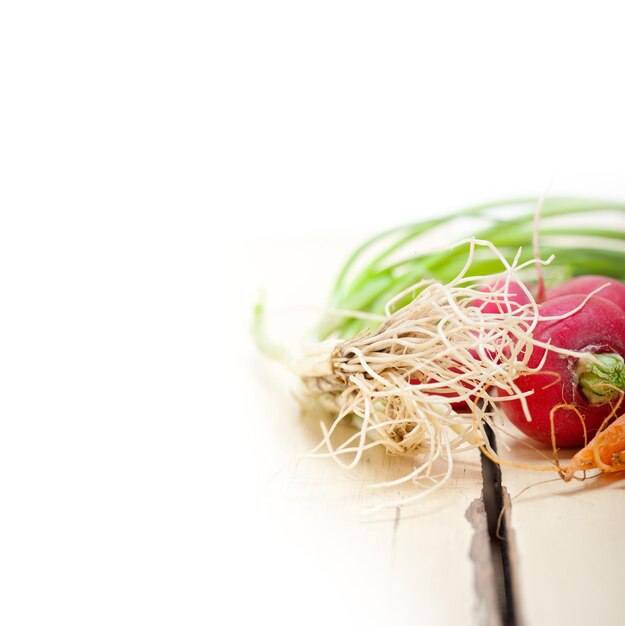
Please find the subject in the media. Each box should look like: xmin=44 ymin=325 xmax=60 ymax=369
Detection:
xmin=494 ymin=432 xmax=625 ymax=626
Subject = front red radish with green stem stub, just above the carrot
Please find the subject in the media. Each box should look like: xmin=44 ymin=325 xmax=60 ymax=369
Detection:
xmin=501 ymin=295 xmax=625 ymax=447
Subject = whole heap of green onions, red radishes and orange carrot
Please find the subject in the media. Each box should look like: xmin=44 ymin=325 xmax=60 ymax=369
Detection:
xmin=257 ymin=198 xmax=625 ymax=501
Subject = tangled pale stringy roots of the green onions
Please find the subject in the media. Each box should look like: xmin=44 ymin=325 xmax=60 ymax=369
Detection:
xmin=302 ymin=239 xmax=552 ymax=504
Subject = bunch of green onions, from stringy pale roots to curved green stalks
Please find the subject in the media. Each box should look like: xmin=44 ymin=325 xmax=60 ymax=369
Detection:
xmin=254 ymin=198 xmax=625 ymax=506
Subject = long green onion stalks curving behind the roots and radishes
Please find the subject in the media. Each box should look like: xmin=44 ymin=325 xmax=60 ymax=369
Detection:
xmin=318 ymin=197 xmax=625 ymax=338
